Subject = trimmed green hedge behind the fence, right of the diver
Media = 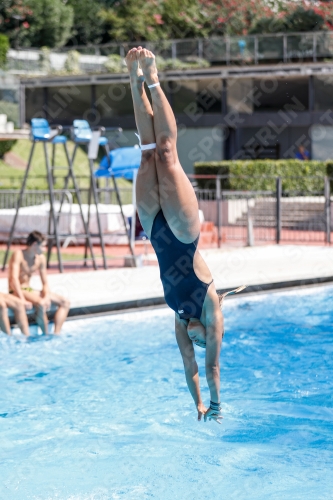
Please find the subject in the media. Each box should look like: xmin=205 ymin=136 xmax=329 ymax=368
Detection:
xmin=194 ymin=160 xmax=333 ymax=192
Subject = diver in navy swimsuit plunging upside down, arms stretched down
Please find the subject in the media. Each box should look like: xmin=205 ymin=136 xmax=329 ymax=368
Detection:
xmin=126 ymin=47 xmax=243 ymax=423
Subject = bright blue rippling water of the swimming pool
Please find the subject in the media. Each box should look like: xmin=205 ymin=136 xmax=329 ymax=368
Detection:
xmin=0 ymin=287 xmax=333 ymax=500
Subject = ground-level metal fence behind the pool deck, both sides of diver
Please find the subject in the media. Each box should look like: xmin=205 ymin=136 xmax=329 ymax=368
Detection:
xmin=0 ymin=176 xmax=333 ymax=247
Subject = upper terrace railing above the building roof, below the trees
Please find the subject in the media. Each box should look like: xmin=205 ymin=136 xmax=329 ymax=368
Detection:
xmin=7 ymin=31 xmax=333 ymax=74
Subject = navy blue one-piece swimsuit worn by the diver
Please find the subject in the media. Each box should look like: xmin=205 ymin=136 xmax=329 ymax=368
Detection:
xmin=151 ymin=210 xmax=212 ymax=319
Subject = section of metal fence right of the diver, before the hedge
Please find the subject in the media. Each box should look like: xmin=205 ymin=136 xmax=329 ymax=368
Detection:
xmin=196 ymin=176 xmax=333 ymax=246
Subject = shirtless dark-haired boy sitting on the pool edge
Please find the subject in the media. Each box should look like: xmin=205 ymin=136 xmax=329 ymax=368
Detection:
xmin=8 ymin=231 xmax=70 ymax=334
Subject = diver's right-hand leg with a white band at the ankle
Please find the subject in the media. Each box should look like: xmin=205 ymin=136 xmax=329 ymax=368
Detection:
xmin=139 ymin=49 xmax=200 ymax=243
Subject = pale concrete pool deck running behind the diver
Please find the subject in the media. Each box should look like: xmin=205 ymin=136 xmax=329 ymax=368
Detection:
xmin=0 ymin=245 xmax=333 ymax=316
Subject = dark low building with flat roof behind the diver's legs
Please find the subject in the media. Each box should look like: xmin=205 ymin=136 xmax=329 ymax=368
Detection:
xmin=20 ymin=62 xmax=333 ymax=173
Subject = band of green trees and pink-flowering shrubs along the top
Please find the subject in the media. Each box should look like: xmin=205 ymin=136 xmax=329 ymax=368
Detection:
xmin=0 ymin=0 xmax=333 ymax=48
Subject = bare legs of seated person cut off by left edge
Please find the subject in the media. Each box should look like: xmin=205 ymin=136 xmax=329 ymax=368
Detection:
xmin=0 ymin=293 xmax=32 ymax=337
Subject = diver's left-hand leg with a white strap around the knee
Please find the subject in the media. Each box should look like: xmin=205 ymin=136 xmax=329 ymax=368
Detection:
xmin=126 ymin=47 xmax=161 ymax=237
